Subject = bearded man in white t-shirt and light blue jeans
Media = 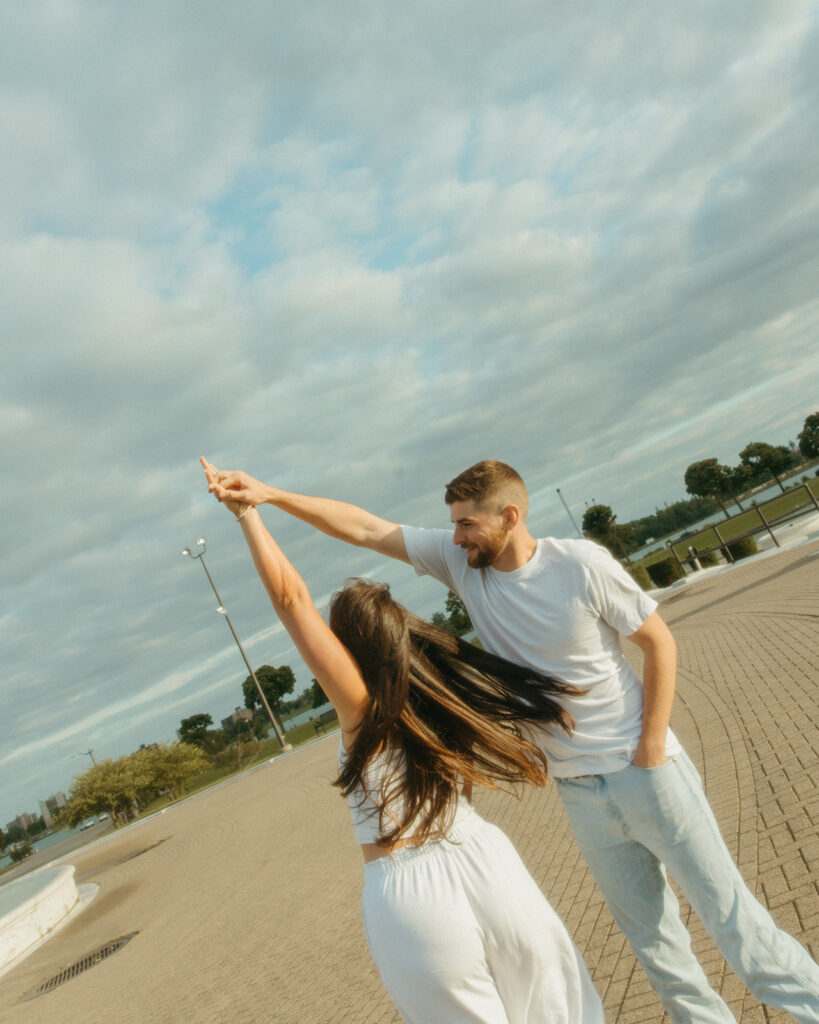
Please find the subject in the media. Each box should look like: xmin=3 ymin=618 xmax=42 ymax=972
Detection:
xmin=206 ymin=461 xmax=819 ymax=1024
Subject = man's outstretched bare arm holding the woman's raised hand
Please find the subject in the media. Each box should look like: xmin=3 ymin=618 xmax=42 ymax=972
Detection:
xmin=204 ymin=469 xmax=410 ymax=562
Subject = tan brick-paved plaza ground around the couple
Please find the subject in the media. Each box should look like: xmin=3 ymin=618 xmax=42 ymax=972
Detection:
xmin=0 ymin=541 xmax=819 ymax=1024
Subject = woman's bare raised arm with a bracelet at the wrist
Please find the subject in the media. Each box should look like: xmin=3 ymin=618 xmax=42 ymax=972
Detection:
xmin=202 ymin=459 xmax=369 ymax=733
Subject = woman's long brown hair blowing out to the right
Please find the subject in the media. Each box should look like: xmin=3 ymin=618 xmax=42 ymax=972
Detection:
xmin=330 ymin=580 xmax=584 ymax=845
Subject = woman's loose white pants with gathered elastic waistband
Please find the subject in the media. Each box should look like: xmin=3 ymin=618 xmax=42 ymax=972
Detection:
xmin=362 ymin=813 xmax=604 ymax=1024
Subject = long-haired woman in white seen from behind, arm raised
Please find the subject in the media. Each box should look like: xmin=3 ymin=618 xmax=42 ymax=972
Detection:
xmin=202 ymin=459 xmax=603 ymax=1024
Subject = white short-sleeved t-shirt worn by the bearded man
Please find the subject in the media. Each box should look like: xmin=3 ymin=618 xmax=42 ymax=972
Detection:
xmin=401 ymin=526 xmax=680 ymax=778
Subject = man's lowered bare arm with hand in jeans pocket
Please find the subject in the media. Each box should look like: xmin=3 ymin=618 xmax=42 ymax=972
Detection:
xmin=628 ymin=611 xmax=677 ymax=768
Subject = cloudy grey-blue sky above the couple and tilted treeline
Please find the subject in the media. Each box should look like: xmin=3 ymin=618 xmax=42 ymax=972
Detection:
xmin=0 ymin=0 xmax=819 ymax=825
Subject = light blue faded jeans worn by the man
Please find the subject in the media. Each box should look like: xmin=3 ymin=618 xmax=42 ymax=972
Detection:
xmin=557 ymin=754 xmax=819 ymax=1024
